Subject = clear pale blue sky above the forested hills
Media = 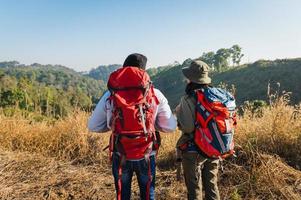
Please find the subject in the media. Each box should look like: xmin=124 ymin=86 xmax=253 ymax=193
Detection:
xmin=0 ymin=0 xmax=301 ymax=71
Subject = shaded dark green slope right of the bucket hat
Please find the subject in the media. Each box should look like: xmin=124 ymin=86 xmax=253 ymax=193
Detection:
xmin=214 ymin=59 xmax=301 ymax=104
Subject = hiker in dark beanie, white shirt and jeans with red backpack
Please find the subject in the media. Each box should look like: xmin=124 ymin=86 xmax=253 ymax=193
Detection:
xmin=88 ymin=53 xmax=176 ymax=200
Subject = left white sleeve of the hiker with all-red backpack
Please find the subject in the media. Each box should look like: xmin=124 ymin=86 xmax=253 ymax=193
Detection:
xmin=88 ymin=91 xmax=111 ymax=133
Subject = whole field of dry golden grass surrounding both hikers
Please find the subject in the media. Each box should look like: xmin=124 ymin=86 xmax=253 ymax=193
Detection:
xmin=0 ymin=98 xmax=301 ymax=200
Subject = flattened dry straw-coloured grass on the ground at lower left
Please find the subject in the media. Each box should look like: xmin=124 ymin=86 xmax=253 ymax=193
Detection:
xmin=0 ymin=152 xmax=113 ymax=200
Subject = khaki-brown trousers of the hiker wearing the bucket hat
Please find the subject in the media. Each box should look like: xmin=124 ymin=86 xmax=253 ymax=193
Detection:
xmin=182 ymin=152 xmax=220 ymax=200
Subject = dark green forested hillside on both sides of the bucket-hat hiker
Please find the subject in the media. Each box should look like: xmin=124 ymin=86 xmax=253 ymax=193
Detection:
xmin=153 ymin=58 xmax=301 ymax=107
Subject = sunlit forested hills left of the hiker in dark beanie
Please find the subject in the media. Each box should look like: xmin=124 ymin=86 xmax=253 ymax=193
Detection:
xmin=0 ymin=61 xmax=105 ymax=117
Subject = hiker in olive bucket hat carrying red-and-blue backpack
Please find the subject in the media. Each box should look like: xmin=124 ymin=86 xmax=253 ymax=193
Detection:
xmin=176 ymin=60 xmax=236 ymax=200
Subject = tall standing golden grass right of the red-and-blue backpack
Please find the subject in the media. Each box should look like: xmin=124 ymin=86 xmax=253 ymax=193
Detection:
xmin=236 ymin=96 xmax=301 ymax=169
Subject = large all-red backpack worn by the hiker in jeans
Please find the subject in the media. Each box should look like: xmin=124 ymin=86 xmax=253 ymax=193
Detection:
xmin=108 ymin=67 xmax=159 ymax=159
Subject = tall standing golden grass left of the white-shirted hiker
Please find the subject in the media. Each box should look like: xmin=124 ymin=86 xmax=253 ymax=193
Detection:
xmin=0 ymin=112 xmax=108 ymax=164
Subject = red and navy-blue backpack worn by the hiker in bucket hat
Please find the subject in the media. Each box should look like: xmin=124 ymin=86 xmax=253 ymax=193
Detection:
xmin=194 ymin=88 xmax=236 ymax=158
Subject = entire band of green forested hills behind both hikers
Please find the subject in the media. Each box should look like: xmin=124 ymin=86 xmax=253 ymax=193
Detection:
xmin=0 ymin=58 xmax=301 ymax=117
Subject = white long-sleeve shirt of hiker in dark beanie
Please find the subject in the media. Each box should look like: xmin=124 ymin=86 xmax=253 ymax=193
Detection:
xmin=88 ymin=89 xmax=177 ymax=132
